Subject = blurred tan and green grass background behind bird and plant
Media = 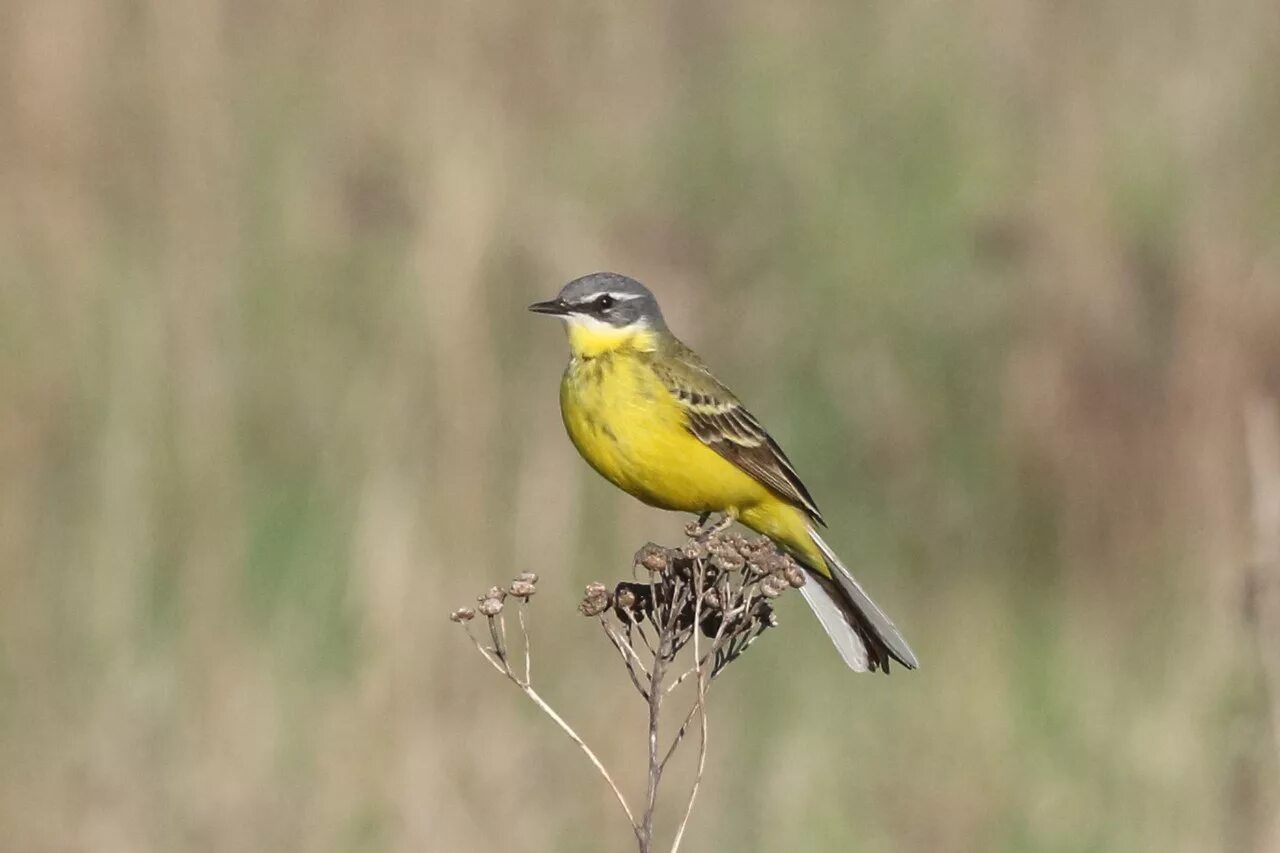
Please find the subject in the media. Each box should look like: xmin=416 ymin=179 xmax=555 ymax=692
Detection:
xmin=0 ymin=0 xmax=1280 ymax=853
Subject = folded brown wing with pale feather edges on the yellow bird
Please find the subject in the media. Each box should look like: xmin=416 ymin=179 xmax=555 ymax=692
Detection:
xmin=660 ymin=351 xmax=826 ymax=525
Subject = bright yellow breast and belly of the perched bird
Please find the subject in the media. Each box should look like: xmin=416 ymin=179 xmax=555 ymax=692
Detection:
xmin=561 ymin=347 xmax=777 ymax=516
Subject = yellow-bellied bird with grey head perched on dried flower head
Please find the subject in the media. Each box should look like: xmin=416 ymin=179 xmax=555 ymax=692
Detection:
xmin=529 ymin=273 xmax=919 ymax=672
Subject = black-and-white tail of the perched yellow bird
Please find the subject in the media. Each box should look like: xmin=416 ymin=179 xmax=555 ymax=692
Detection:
xmin=800 ymin=526 xmax=919 ymax=672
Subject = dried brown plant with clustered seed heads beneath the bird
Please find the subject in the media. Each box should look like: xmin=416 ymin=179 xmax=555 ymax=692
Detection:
xmin=451 ymin=524 xmax=805 ymax=853
